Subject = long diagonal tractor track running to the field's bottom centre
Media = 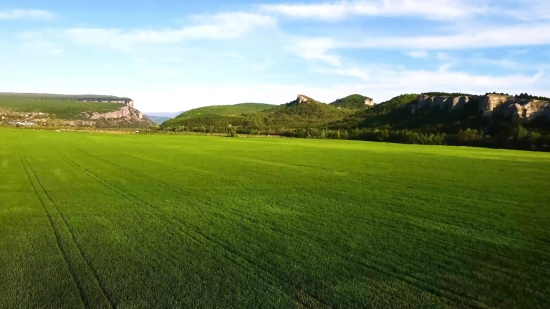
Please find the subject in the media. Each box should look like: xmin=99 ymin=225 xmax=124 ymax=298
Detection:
xmin=64 ymin=157 xmax=310 ymax=308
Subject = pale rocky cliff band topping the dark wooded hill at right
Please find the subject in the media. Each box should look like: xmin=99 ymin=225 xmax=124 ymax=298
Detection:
xmin=410 ymin=94 xmax=550 ymax=121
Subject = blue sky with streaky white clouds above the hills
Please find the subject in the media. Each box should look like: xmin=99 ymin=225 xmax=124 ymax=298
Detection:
xmin=0 ymin=0 xmax=550 ymax=112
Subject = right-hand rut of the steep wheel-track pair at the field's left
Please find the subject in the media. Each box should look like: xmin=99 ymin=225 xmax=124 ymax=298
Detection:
xmin=24 ymin=157 xmax=116 ymax=309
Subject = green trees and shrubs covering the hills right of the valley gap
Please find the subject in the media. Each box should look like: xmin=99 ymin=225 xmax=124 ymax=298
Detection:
xmin=160 ymin=92 xmax=550 ymax=150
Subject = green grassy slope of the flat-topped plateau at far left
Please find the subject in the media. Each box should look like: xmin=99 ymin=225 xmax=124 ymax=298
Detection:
xmin=0 ymin=96 xmax=124 ymax=120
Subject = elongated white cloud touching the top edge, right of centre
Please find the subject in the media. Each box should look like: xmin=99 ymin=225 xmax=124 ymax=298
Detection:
xmin=260 ymin=0 xmax=488 ymax=20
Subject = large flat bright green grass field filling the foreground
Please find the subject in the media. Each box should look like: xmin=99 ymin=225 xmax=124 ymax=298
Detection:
xmin=0 ymin=130 xmax=550 ymax=309
